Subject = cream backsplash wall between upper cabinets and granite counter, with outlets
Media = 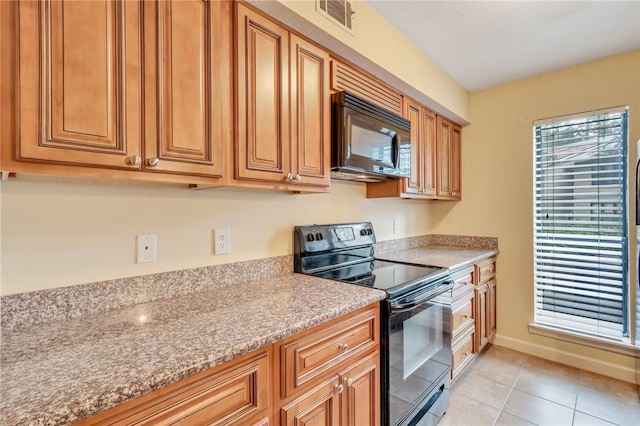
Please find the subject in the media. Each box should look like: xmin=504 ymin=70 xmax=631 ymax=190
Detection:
xmin=0 ymin=181 xmax=429 ymax=295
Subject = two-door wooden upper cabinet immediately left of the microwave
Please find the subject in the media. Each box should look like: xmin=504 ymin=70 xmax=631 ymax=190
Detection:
xmin=234 ymin=3 xmax=331 ymax=191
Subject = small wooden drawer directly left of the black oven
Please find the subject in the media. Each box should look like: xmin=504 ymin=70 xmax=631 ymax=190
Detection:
xmin=280 ymin=304 xmax=380 ymax=397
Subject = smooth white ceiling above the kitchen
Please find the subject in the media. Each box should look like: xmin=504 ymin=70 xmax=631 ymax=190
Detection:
xmin=364 ymin=0 xmax=640 ymax=91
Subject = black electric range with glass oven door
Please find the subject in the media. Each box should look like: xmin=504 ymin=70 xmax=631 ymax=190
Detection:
xmin=293 ymin=222 xmax=453 ymax=426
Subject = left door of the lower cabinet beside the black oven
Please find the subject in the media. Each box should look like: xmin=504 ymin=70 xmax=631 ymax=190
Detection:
xmin=280 ymin=375 xmax=344 ymax=426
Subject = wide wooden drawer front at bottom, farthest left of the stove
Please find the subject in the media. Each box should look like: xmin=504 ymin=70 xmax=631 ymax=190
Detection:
xmin=78 ymin=350 xmax=271 ymax=425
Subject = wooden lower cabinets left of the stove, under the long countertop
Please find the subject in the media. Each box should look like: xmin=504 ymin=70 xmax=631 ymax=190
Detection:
xmin=77 ymin=303 xmax=381 ymax=426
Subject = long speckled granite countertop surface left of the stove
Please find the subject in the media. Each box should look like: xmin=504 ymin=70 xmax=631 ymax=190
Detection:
xmin=0 ymin=273 xmax=385 ymax=425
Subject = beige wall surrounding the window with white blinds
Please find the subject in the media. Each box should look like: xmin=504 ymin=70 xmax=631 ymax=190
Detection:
xmin=429 ymin=51 xmax=640 ymax=382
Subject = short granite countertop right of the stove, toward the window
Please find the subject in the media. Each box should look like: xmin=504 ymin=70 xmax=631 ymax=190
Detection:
xmin=378 ymin=245 xmax=498 ymax=271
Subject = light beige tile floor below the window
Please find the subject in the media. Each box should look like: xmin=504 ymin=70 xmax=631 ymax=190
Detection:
xmin=438 ymin=346 xmax=640 ymax=426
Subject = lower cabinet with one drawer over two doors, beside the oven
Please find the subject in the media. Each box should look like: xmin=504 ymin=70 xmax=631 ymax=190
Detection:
xmin=275 ymin=304 xmax=381 ymax=426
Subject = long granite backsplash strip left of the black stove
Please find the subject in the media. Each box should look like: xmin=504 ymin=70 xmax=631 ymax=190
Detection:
xmin=0 ymin=256 xmax=293 ymax=329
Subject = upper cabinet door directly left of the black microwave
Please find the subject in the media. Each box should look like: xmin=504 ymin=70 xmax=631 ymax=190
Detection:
xmin=290 ymin=34 xmax=331 ymax=186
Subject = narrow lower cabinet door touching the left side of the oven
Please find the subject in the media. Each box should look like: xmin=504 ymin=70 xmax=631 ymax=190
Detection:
xmin=341 ymin=353 xmax=380 ymax=426
